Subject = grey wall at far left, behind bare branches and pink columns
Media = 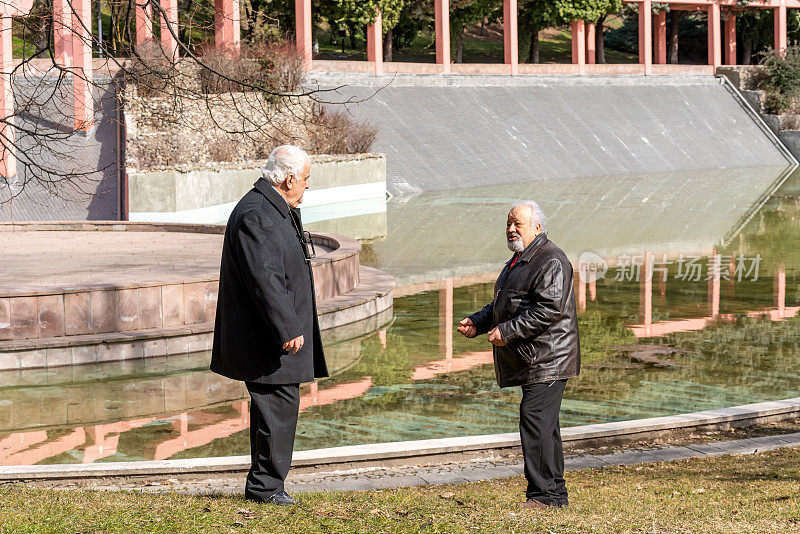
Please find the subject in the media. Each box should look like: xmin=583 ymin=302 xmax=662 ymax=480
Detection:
xmin=0 ymin=74 xmax=124 ymax=222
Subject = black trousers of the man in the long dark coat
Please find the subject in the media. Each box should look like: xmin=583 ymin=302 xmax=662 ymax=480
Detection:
xmin=244 ymin=382 xmax=300 ymax=500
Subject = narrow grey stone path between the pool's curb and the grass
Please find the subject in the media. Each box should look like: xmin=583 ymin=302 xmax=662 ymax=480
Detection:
xmin=69 ymin=432 xmax=800 ymax=495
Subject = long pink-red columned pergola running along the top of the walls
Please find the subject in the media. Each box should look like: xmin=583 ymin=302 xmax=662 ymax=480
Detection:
xmin=0 ymin=0 xmax=800 ymax=177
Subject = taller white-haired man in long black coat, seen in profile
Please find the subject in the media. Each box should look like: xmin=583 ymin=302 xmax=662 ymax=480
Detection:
xmin=211 ymin=145 xmax=328 ymax=504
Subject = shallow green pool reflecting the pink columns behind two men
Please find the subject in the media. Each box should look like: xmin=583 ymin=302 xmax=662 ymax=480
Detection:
xmin=0 ymin=168 xmax=800 ymax=465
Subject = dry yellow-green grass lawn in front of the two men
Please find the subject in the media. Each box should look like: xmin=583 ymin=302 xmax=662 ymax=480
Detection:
xmin=0 ymin=449 xmax=800 ymax=533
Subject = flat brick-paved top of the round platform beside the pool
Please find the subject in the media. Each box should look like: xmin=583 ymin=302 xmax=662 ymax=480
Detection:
xmin=0 ymin=231 xmax=223 ymax=295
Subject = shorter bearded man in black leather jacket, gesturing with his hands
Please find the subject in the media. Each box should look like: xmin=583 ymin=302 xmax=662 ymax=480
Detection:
xmin=458 ymin=201 xmax=580 ymax=508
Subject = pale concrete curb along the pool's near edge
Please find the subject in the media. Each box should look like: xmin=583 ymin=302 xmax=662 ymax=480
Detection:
xmin=0 ymin=397 xmax=800 ymax=481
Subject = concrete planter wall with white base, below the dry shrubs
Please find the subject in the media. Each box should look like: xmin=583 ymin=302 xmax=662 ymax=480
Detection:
xmin=128 ymin=154 xmax=386 ymax=239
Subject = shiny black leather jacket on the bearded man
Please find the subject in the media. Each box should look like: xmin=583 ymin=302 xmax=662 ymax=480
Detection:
xmin=470 ymin=234 xmax=581 ymax=387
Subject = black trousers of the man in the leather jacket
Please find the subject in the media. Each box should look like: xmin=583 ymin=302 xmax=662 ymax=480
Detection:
xmin=519 ymin=380 xmax=567 ymax=506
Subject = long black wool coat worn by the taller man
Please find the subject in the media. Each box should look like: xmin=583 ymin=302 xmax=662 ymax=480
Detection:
xmin=211 ymin=178 xmax=328 ymax=384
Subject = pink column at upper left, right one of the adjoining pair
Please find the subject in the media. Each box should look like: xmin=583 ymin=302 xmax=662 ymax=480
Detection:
xmin=70 ymin=0 xmax=94 ymax=130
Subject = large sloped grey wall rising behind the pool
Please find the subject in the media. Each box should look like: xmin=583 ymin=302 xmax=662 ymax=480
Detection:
xmin=310 ymin=74 xmax=787 ymax=195
